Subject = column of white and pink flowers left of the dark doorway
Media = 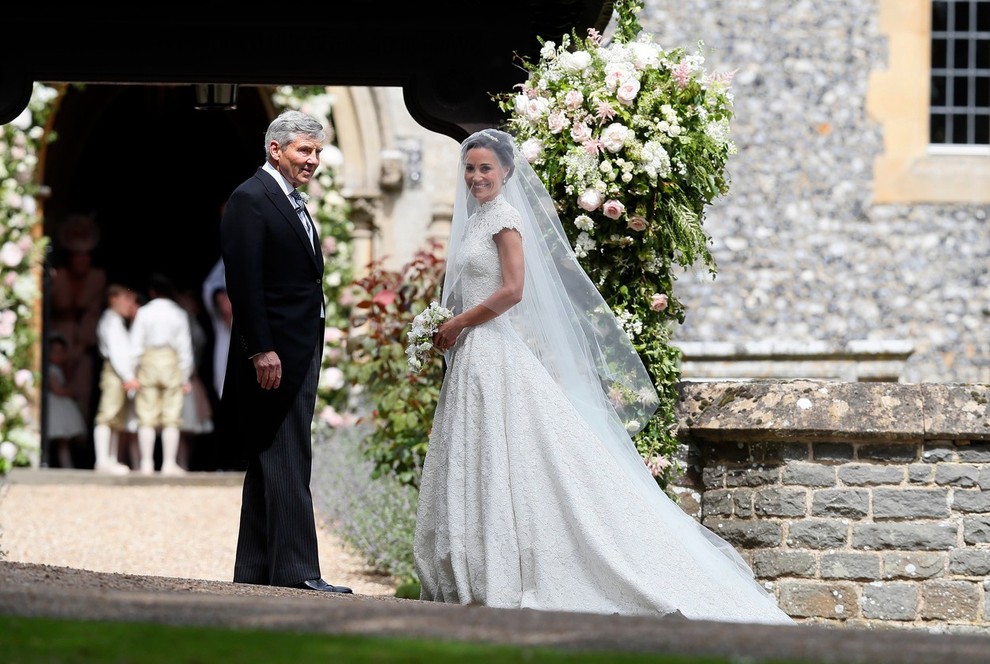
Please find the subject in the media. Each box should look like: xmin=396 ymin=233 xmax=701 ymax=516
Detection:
xmin=0 ymin=83 xmax=58 ymax=475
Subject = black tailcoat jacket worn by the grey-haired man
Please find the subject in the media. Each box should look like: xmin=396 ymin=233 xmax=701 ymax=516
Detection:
xmin=220 ymin=168 xmax=324 ymax=453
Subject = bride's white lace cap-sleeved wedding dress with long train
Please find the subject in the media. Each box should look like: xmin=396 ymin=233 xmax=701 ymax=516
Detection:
xmin=415 ymin=199 xmax=792 ymax=623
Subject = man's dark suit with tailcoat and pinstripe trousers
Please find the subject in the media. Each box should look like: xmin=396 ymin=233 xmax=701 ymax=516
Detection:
xmin=220 ymin=169 xmax=324 ymax=586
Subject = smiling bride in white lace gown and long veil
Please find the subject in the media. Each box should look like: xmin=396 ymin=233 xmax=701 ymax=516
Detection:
xmin=414 ymin=129 xmax=793 ymax=624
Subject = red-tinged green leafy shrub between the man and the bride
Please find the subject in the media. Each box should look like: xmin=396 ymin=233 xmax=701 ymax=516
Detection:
xmin=342 ymin=242 xmax=444 ymax=487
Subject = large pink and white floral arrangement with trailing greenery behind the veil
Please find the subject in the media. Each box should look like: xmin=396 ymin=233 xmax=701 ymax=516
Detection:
xmin=496 ymin=0 xmax=736 ymax=483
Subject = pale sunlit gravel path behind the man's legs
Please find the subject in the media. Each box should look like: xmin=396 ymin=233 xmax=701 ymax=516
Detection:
xmin=0 ymin=469 xmax=395 ymax=597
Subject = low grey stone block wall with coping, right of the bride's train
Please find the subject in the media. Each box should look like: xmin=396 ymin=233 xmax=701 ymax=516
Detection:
xmin=678 ymin=380 xmax=990 ymax=632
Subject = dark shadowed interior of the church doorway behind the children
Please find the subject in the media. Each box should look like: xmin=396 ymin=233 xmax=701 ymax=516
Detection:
xmin=43 ymin=84 xmax=271 ymax=470
